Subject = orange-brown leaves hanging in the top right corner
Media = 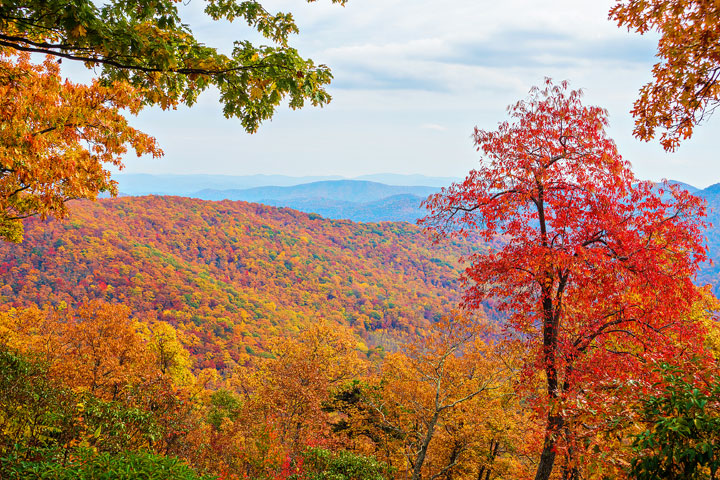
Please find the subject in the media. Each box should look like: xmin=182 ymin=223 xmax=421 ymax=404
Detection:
xmin=610 ymin=0 xmax=720 ymax=151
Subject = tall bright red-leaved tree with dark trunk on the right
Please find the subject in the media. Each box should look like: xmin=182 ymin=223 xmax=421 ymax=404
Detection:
xmin=423 ymin=79 xmax=705 ymax=480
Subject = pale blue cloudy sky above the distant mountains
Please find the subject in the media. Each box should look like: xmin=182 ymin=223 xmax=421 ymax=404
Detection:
xmin=98 ymin=0 xmax=720 ymax=188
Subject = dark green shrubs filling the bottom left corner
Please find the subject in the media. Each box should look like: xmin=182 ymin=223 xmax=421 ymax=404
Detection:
xmin=0 ymin=346 xmax=210 ymax=480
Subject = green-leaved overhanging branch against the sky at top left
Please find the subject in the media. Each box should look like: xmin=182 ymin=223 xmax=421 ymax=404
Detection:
xmin=0 ymin=0 xmax=345 ymax=132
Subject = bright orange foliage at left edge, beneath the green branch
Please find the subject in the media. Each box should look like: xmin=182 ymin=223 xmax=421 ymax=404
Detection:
xmin=0 ymin=51 xmax=162 ymax=242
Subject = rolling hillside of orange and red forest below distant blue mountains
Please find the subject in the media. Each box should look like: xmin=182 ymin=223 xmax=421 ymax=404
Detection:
xmin=0 ymin=197 xmax=476 ymax=368
